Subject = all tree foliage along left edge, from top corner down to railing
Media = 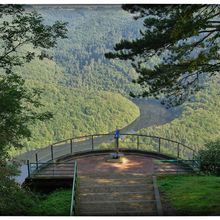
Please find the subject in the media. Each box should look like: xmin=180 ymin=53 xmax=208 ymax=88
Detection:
xmin=0 ymin=5 xmax=67 ymax=159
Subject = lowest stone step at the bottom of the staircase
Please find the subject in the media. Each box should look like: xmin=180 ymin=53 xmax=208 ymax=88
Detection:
xmin=78 ymin=200 xmax=156 ymax=213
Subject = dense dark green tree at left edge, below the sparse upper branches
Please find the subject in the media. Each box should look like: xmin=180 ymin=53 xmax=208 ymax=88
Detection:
xmin=0 ymin=74 xmax=52 ymax=159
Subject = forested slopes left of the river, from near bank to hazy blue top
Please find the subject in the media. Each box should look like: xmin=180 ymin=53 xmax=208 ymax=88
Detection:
xmin=2 ymin=6 xmax=150 ymax=155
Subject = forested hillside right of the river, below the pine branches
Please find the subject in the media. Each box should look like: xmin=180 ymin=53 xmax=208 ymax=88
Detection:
xmin=140 ymin=74 xmax=220 ymax=149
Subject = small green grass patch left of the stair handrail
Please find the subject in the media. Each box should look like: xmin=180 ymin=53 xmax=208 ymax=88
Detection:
xmin=30 ymin=189 xmax=72 ymax=216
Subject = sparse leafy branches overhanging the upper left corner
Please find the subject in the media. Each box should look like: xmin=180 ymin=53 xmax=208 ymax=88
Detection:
xmin=0 ymin=5 xmax=67 ymax=73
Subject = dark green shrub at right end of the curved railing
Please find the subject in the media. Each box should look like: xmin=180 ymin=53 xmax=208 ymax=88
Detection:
xmin=198 ymin=140 xmax=220 ymax=175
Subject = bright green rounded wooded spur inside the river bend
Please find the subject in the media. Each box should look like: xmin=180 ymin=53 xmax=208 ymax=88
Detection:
xmin=21 ymin=81 xmax=139 ymax=148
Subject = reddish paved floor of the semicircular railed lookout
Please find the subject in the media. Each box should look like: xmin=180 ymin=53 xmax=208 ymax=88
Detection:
xmin=31 ymin=153 xmax=187 ymax=177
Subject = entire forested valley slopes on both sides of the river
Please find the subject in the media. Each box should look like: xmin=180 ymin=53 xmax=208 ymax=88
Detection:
xmin=5 ymin=5 xmax=220 ymax=155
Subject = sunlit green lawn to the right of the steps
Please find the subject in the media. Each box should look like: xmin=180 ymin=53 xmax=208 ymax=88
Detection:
xmin=158 ymin=175 xmax=220 ymax=215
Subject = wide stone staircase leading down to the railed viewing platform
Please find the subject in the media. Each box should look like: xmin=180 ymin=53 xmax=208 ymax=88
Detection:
xmin=77 ymin=172 xmax=162 ymax=216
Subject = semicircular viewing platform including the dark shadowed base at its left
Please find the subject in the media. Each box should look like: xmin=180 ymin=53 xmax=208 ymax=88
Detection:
xmin=23 ymin=151 xmax=192 ymax=191
